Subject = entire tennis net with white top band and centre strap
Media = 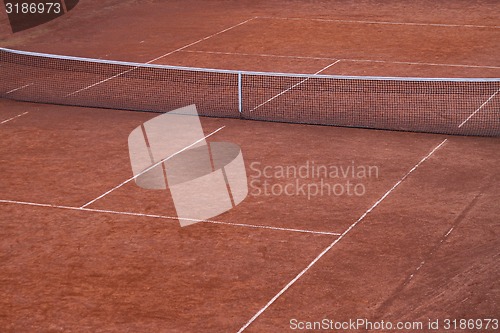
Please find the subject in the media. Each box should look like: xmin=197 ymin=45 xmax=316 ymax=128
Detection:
xmin=0 ymin=48 xmax=500 ymax=136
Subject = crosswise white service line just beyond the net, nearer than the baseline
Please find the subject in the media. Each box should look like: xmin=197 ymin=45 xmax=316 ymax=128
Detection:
xmin=182 ymin=50 xmax=500 ymax=69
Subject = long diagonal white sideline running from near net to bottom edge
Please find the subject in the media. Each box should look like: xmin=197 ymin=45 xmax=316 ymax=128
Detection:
xmin=238 ymin=139 xmax=448 ymax=333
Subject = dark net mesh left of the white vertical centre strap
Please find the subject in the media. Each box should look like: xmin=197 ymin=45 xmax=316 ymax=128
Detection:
xmin=0 ymin=50 xmax=239 ymax=117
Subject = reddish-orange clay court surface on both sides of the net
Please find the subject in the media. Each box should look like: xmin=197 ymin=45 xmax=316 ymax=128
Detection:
xmin=0 ymin=0 xmax=500 ymax=332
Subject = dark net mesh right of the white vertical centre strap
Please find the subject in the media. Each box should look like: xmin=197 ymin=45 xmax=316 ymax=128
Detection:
xmin=243 ymin=75 xmax=500 ymax=136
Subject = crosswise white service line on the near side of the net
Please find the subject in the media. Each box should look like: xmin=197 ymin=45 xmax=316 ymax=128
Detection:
xmin=0 ymin=200 xmax=340 ymax=236
